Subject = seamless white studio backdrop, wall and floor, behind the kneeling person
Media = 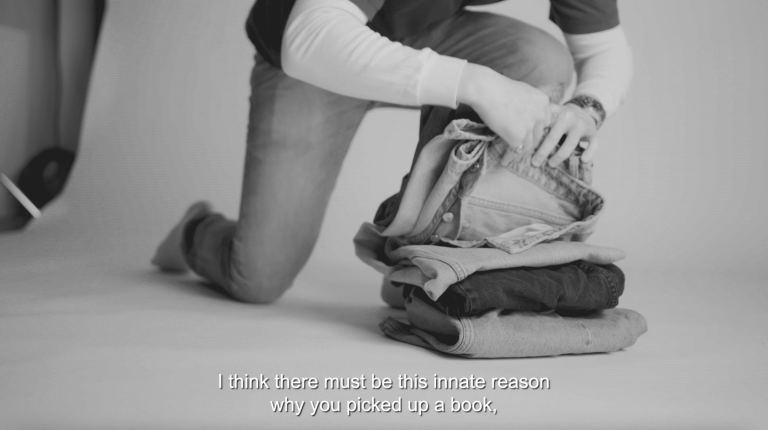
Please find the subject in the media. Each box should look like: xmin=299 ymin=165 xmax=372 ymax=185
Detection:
xmin=0 ymin=0 xmax=768 ymax=428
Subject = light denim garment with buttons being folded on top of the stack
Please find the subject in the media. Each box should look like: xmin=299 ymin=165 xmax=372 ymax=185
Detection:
xmin=374 ymin=119 xmax=604 ymax=254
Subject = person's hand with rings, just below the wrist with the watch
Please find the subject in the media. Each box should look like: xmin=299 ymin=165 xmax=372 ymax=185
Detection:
xmin=531 ymin=104 xmax=597 ymax=167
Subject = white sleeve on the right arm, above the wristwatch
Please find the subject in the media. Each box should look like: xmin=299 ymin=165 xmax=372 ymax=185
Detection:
xmin=565 ymin=26 xmax=632 ymax=116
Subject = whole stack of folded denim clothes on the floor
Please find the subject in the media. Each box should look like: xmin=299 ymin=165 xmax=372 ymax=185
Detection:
xmin=355 ymin=113 xmax=647 ymax=357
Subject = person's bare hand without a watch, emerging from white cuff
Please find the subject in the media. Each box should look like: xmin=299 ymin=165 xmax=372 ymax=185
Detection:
xmin=457 ymin=63 xmax=552 ymax=166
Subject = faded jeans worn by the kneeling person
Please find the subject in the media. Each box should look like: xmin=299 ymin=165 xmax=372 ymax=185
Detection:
xmin=183 ymin=11 xmax=574 ymax=302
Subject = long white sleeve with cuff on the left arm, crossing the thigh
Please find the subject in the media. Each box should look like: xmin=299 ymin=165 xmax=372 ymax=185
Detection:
xmin=281 ymin=0 xmax=466 ymax=108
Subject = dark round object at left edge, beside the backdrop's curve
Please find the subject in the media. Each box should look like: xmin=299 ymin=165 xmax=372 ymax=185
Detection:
xmin=18 ymin=148 xmax=75 ymax=213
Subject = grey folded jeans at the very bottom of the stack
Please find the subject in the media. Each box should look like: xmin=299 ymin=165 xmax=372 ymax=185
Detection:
xmin=379 ymin=288 xmax=648 ymax=358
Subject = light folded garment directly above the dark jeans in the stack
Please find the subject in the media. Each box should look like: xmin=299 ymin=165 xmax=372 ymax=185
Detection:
xmin=354 ymin=223 xmax=625 ymax=300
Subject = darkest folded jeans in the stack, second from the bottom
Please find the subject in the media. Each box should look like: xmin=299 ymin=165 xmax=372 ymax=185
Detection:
xmin=437 ymin=260 xmax=624 ymax=316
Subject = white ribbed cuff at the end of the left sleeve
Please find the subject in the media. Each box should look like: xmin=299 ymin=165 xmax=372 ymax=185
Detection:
xmin=417 ymin=51 xmax=467 ymax=109
